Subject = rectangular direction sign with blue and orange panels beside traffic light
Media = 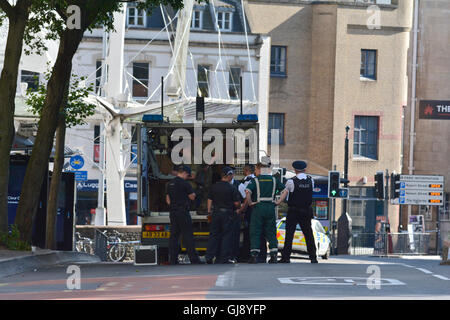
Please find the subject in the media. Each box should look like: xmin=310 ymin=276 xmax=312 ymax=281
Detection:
xmin=392 ymin=175 xmax=444 ymax=206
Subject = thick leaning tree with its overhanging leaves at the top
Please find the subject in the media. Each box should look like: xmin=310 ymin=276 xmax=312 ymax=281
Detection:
xmin=16 ymin=0 xmax=183 ymax=241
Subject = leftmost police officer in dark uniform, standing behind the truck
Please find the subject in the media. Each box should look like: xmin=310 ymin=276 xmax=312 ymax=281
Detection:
xmin=166 ymin=165 xmax=202 ymax=264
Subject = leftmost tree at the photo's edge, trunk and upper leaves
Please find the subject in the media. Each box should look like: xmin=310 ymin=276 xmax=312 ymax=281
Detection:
xmin=0 ymin=0 xmax=67 ymax=232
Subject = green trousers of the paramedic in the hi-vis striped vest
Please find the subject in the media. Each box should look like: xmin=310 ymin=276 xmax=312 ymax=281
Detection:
xmin=250 ymin=202 xmax=278 ymax=255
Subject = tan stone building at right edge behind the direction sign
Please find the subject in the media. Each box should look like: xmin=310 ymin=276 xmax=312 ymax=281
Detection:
xmin=401 ymin=0 xmax=450 ymax=250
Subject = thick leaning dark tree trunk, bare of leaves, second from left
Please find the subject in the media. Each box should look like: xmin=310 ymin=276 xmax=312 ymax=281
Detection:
xmin=16 ymin=29 xmax=84 ymax=241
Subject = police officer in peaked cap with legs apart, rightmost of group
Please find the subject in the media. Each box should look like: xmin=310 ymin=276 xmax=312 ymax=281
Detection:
xmin=279 ymin=161 xmax=317 ymax=263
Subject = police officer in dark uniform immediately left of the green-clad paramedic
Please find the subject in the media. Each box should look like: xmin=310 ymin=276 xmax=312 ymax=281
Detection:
xmin=206 ymin=167 xmax=241 ymax=264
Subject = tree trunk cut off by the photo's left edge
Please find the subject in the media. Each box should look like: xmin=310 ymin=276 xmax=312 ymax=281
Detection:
xmin=0 ymin=5 xmax=28 ymax=232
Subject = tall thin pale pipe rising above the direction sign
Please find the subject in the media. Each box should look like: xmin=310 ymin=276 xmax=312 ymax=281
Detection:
xmin=408 ymin=0 xmax=420 ymax=222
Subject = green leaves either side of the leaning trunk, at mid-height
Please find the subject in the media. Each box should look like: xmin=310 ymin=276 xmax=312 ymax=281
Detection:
xmin=26 ymin=68 xmax=95 ymax=128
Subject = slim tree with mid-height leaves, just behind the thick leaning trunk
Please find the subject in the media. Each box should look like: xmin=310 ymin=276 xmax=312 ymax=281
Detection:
xmin=26 ymin=73 xmax=95 ymax=249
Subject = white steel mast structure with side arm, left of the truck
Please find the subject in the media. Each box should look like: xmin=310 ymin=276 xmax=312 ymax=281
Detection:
xmin=96 ymin=0 xmax=194 ymax=226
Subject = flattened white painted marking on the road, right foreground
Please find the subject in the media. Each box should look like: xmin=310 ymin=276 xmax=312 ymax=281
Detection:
xmin=278 ymin=277 xmax=405 ymax=286
